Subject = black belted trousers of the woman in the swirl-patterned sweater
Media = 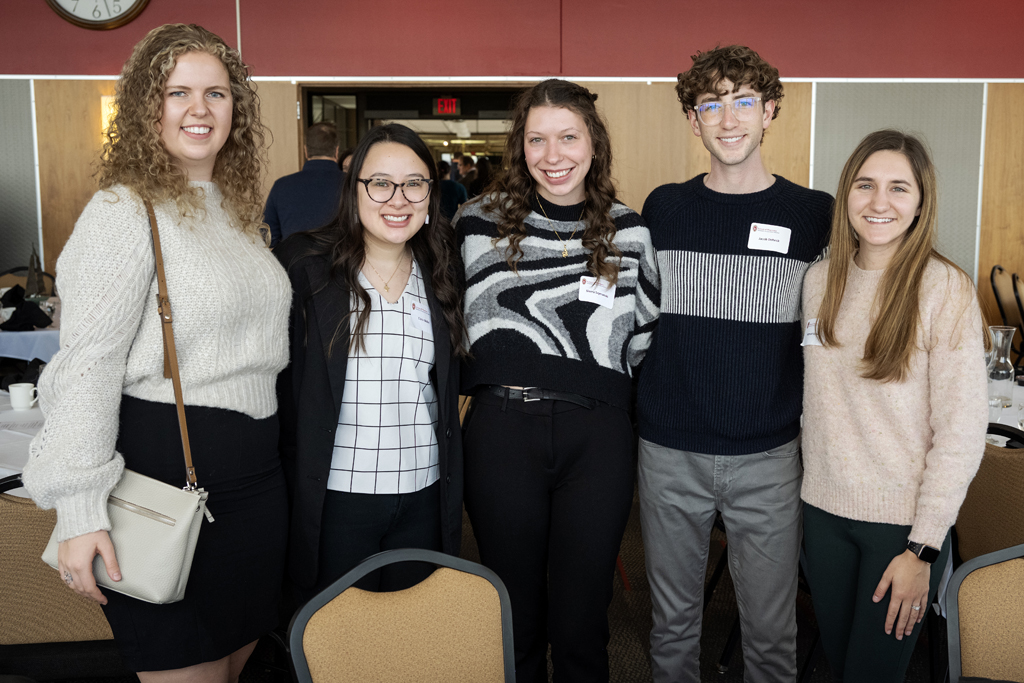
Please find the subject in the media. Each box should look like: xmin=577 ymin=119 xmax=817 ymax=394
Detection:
xmin=463 ymin=392 xmax=634 ymax=683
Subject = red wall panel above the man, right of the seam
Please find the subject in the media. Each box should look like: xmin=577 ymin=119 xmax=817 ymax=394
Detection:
xmin=561 ymin=0 xmax=1024 ymax=78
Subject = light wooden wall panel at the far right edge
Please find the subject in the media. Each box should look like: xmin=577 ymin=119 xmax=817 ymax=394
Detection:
xmin=978 ymin=83 xmax=1024 ymax=327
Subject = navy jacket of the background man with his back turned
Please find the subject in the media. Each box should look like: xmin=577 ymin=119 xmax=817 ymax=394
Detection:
xmin=263 ymin=159 xmax=345 ymax=247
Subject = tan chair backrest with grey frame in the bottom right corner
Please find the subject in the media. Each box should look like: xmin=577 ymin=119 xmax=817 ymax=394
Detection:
xmin=946 ymin=545 xmax=1024 ymax=683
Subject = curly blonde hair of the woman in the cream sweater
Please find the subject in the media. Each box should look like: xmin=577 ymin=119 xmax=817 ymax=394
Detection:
xmin=98 ymin=24 xmax=266 ymax=236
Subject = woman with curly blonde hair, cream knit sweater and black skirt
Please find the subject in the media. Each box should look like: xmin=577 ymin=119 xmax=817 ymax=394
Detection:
xmin=25 ymin=24 xmax=290 ymax=683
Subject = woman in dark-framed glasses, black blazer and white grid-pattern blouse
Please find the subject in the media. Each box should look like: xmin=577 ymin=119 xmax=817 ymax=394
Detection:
xmin=274 ymin=124 xmax=466 ymax=600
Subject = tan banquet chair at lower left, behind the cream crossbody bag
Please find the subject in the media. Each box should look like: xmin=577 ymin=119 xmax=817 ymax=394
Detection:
xmin=0 ymin=474 xmax=131 ymax=681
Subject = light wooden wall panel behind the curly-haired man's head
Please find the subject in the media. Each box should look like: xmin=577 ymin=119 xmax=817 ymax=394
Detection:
xmin=584 ymin=83 xmax=811 ymax=211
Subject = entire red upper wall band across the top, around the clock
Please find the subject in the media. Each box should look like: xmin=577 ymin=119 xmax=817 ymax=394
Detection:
xmin=0 ymin=0 xmax=1024 ymax=78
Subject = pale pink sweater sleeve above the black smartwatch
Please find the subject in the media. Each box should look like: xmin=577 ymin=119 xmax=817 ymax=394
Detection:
xmin=910 ymin=267 xmax=988 ymax=548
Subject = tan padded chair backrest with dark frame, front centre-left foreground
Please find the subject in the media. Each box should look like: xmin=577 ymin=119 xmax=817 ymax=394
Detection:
xmin=289 ymin=549 xmax=515 ymax=683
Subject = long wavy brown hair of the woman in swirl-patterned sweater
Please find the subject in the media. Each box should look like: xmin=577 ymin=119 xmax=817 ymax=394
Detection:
xmin=483 ymin=78 xmax=622 ymax=284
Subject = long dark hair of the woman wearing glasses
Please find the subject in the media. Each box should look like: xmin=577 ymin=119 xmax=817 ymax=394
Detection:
xmin=310 ymin=123 xmax=466 ymax=355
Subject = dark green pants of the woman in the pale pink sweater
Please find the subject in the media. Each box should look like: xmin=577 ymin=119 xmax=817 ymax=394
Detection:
xmin=804 ymin=503 xmax=949 ymax=683
